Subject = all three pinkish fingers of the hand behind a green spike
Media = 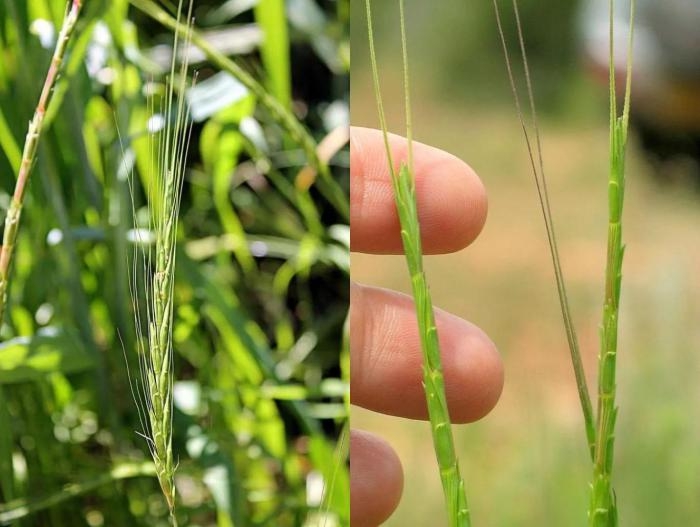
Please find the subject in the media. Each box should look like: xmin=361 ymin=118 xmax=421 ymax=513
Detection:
xmin=350 ymin=127 xmax=503 ymax=527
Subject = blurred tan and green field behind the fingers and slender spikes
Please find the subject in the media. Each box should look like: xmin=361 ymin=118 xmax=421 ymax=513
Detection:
xmin=351 ymin=0 xmax=700 ymax=527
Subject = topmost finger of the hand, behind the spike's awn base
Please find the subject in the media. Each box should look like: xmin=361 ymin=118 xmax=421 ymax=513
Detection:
xmin=350 ymin=127 xmax=488 ymax=254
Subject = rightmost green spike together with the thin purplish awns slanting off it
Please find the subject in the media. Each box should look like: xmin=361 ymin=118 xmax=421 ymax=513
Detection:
xmin=493 ymin=0 xmax=635 ymax=527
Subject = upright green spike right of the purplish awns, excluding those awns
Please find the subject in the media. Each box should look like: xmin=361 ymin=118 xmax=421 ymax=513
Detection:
xmin=588 ymin=0 xmax=635 ymax=527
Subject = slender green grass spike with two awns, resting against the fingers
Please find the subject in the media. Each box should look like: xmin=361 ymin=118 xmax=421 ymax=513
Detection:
xmin=365 ymin=0 xmax=471 ymax=527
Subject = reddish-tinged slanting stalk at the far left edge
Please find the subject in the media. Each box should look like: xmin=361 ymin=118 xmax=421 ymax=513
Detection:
xmin=0 ymin=0 xmax=82 ymax=324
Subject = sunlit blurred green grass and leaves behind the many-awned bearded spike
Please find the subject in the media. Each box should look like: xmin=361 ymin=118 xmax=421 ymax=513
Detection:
xmin=0 ymin=0 xmax=349 ymax=527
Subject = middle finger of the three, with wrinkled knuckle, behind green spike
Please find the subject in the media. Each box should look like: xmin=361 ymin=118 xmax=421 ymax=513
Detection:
xmin=350 ymin=284 xmax=504 ymax=423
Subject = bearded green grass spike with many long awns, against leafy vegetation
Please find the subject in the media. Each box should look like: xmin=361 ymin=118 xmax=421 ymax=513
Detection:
xmin=131 ymin=0 xmax=192 ymax=525
